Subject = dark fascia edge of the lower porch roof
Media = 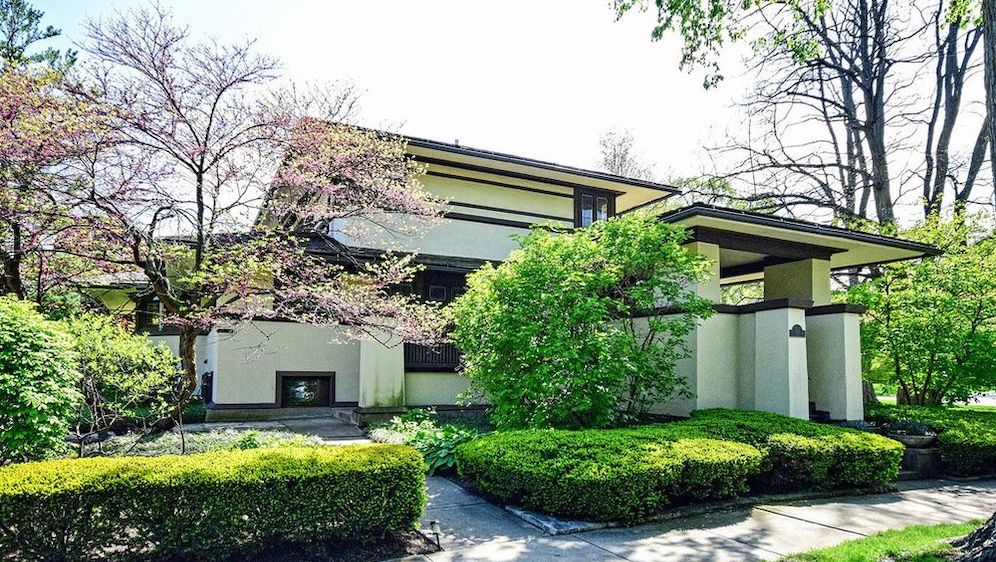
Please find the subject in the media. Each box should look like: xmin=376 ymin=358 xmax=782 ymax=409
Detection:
xmin=660 ymin=203 xmax=944 ymax=256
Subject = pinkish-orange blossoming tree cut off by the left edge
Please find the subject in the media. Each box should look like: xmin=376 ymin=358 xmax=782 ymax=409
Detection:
xmin=0 ymin=70 xmax=102 ymax=302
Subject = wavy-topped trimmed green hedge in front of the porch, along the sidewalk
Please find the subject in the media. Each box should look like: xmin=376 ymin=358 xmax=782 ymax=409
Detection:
xmin=457 ymin=410 xmax=903 ymax=523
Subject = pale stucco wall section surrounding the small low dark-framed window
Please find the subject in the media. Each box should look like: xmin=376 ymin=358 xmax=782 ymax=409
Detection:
xmin=214 ymin=322 xmax=359 ymax=405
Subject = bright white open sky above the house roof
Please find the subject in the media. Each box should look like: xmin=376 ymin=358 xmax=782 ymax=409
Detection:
xmin=33 ymin=0 xmax=748 ymax=176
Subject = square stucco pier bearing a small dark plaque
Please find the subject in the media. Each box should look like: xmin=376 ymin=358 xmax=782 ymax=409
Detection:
xmin=752 ymin=308 xmax=809 ymax=419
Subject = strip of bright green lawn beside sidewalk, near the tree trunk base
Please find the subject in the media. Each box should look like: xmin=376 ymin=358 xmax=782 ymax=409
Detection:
xmin=781 ymin=521 xmax=982 ymax=562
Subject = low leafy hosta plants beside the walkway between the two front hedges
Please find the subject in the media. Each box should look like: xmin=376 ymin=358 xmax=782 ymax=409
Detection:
xmin=370 ymin=408 xmax=481 ymax=475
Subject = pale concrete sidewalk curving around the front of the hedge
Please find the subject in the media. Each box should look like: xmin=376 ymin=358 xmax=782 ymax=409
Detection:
xmin=405 ymin=477 xmax=996 ymax=562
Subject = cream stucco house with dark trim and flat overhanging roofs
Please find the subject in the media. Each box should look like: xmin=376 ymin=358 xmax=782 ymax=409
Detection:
xmin=87 ymin=138 xmax=937 ymax=421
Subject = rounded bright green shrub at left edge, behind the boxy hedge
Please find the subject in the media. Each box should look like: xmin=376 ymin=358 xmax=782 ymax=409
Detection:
xmin=0 ymin=296 xmax=78 ymax=465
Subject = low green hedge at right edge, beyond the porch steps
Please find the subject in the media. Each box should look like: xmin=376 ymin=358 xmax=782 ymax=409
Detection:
xmin=865 ymin=405 xmax=996 ymax=476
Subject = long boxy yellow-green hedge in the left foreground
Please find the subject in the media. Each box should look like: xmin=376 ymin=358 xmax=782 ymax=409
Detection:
xmin=0 ymin=445 xmax=426 ymax=561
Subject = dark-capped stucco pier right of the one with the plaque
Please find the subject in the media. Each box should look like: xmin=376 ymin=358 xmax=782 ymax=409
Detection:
xmin=806 ymin=304 xmax=864 ymax=421
